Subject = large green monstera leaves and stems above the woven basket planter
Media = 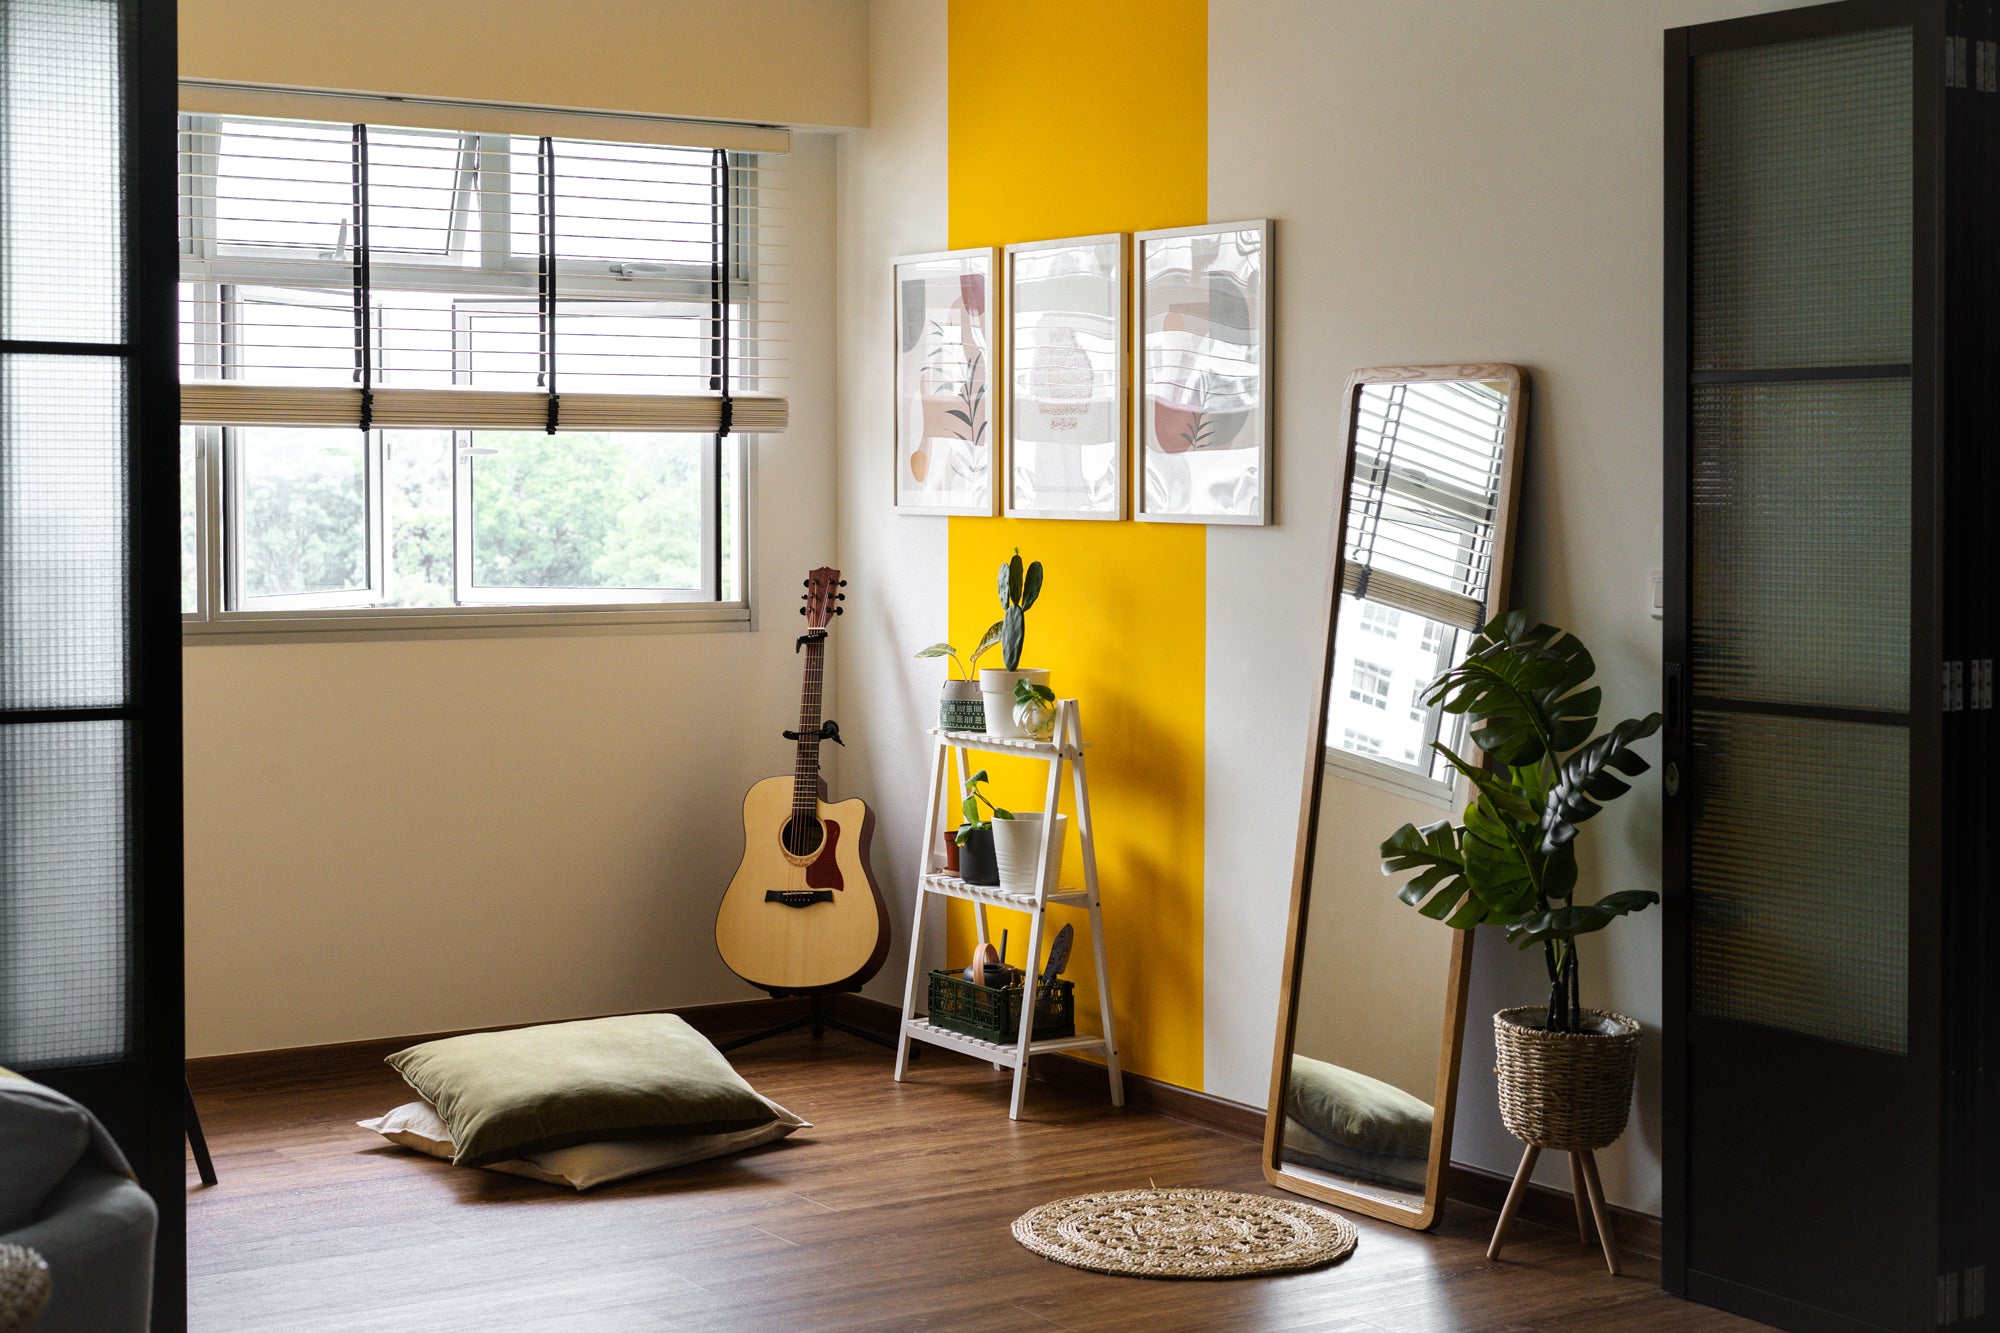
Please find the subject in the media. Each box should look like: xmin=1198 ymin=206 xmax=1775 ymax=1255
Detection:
xmin=1382 ymin=610 xmax=1660 ymax=1033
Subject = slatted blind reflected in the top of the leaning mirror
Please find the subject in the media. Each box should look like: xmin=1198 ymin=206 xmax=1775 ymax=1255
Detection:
xmin=1342 ymin=380 xmax=1508 ymax=628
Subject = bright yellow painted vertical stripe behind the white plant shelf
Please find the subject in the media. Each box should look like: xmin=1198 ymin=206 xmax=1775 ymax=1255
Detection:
xmin=946 ymin=0 xmax=1208 ymax=1089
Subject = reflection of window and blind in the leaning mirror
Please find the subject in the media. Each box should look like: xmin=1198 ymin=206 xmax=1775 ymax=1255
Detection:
xmin=1326 ymin=380 xmax=1508 ymax=801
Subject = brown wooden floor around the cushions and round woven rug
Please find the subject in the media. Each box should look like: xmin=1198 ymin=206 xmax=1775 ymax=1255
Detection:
xmin=188 ymin=1033 xmax=1758 ymax=1333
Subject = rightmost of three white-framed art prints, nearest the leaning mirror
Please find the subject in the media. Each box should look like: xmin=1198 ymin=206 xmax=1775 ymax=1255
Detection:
xmin=1132 ymin=220 xmax=1272 ymax=524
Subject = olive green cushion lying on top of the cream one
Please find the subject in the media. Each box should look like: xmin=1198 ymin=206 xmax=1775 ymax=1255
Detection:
xmin=388 ymin=1013 xmax=776 ymax=1167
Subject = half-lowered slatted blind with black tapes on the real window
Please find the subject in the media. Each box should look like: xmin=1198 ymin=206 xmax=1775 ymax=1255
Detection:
xmin=180 ymin=114 xmax=790 ymax=434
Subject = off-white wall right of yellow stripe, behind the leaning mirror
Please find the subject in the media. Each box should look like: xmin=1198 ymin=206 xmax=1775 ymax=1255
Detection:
xmin=1206 ymin=0 xmax=1816 ymax=1213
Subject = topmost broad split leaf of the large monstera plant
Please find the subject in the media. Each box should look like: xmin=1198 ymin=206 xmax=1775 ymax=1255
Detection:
xmin=1424 ymin=610 xmax=1604 ymax=769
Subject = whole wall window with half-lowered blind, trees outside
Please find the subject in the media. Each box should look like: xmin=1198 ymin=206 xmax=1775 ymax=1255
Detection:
xmin=180 ymin=114 xmax=786 ymax=628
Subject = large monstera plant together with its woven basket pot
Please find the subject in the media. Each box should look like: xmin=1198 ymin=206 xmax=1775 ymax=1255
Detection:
xmin=1382 ymin=610 xmax=1660 ymax=1184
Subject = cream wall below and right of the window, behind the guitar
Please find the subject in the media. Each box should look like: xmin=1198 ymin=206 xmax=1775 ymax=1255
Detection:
xmin=184 ymin=134 xmax=844 ymax=1055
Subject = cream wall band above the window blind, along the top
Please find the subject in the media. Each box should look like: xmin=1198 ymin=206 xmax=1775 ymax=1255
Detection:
xmin=180 ymin=0 xmax=868 ymax=126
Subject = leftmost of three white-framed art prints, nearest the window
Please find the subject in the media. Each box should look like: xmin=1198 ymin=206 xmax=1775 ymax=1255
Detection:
xmin=896 ymin=248 xmax=1000 ymax=518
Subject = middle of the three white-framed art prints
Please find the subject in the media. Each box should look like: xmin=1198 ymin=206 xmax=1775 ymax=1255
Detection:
xmin=1006 ymin=234 xmax=1126 ymax=518
